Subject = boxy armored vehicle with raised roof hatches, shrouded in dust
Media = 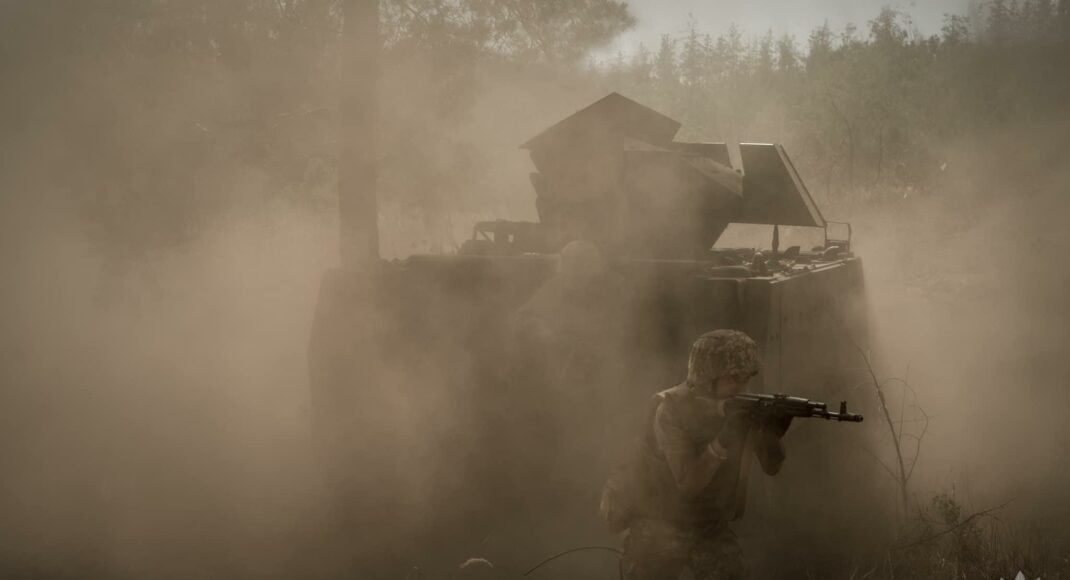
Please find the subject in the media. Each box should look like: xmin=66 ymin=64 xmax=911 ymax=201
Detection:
xmin=310 ymin=93 xmax=867 ymax=577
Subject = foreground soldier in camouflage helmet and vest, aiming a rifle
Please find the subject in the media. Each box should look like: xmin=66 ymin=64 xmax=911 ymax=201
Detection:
xmin=600 ymin=330 xmax=792 ymax=580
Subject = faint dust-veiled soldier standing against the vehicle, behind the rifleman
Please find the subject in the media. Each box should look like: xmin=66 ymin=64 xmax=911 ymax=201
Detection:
xmin=496 ymin=241 xmax=629 ymax=565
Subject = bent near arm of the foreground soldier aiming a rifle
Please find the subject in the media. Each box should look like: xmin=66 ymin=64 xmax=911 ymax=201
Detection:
xmin=654 ymin=405 xmax=728 ymax=495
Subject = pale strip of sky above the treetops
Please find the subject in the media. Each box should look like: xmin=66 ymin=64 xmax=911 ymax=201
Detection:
xmin=605 ymin=0 xmax=979 ymax=55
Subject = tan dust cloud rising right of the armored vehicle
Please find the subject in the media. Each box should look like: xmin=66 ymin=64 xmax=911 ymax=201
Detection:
xmin=855 ymin=119 xmax=1070 ymax=522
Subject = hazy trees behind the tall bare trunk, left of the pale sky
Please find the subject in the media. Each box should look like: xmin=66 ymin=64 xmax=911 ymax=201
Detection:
xmin=0 ymin=0 xmax=633 ymax=261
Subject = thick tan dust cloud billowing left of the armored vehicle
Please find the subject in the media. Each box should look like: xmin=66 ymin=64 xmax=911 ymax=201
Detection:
xmin=0 ymin=188 xmax=333 ymax=578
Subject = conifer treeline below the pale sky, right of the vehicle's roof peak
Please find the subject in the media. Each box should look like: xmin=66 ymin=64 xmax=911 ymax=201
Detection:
xmin=600 ymin=0 xmax=1070 ymax=209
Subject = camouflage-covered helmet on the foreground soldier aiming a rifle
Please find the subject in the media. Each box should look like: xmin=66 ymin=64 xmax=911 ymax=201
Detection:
xmin=687 ymin=330 xmax=762 ymax=385
